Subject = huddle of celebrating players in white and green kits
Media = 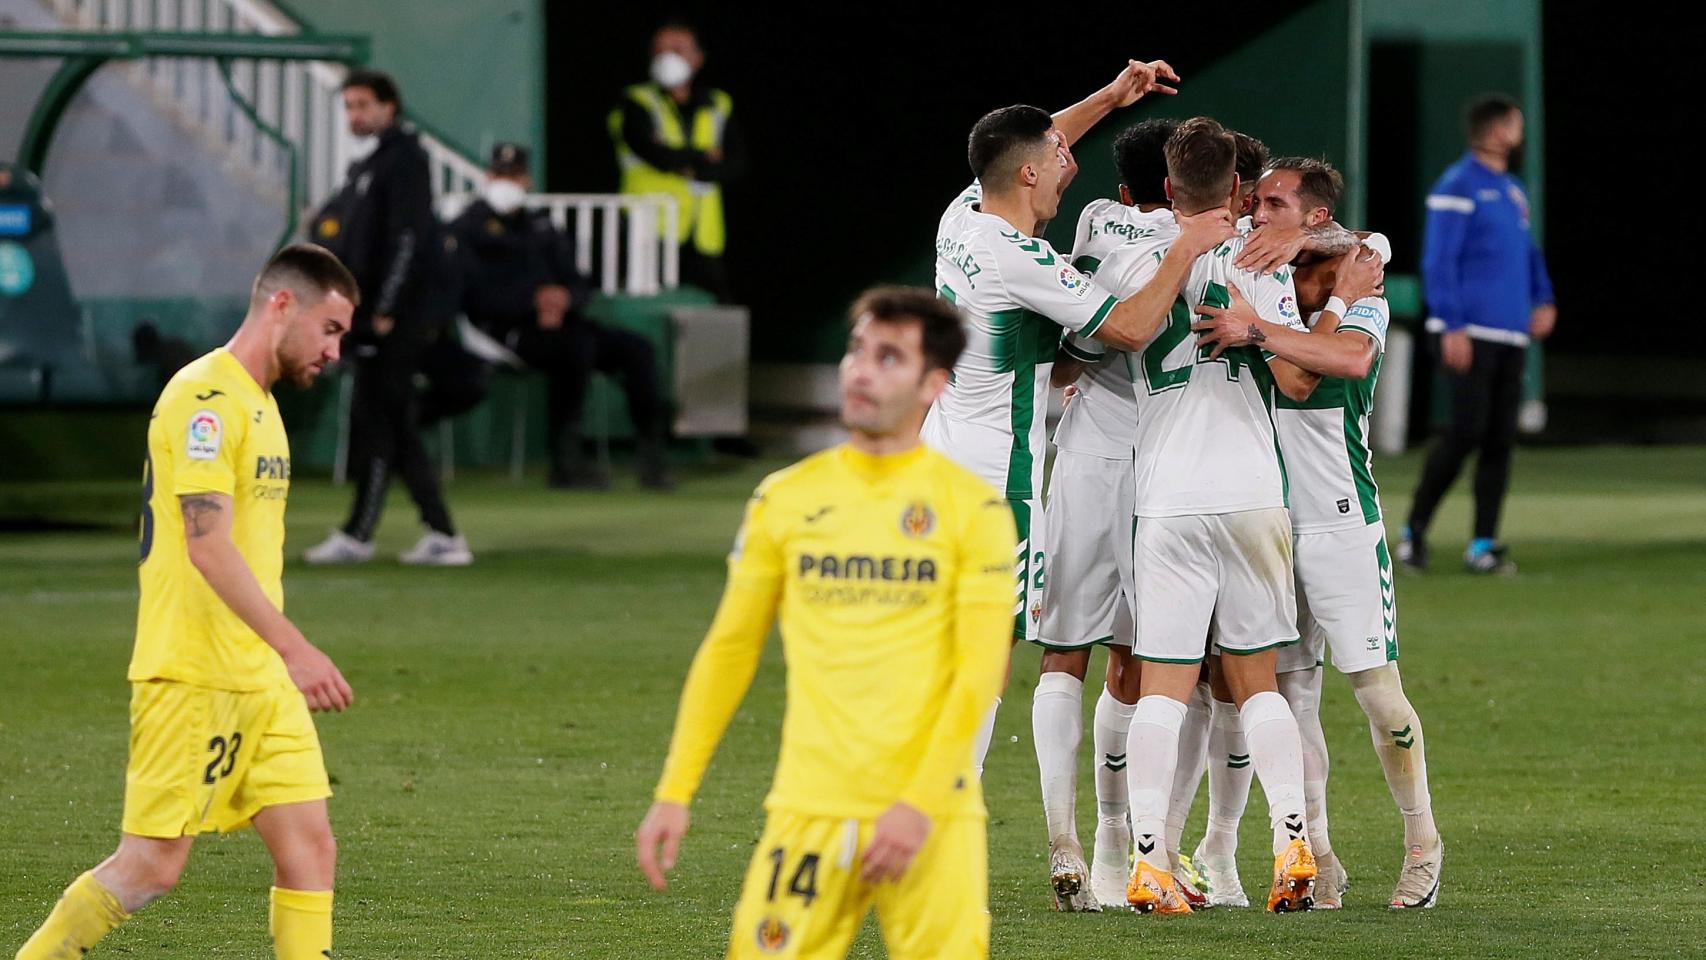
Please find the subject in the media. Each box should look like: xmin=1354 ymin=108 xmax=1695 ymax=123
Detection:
xmin=923 ymin=61 xmax=1443 ymax=912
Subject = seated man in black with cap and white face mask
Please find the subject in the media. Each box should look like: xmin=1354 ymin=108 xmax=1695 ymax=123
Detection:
xmin=449 ymin=143 xmax=669 ymax=489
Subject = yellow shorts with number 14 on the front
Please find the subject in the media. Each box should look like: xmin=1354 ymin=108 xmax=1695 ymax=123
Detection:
xmin=728 ymin=812 xmax=989 ymax=960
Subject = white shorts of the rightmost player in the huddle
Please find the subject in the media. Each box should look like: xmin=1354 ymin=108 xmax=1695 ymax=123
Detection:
xmin=1280 ymin=523 xmax=1397 ymax=674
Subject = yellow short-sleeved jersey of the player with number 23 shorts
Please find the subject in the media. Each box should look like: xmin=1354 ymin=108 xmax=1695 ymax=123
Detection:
xmin=130 ymin=348 xmax=290 ymax=691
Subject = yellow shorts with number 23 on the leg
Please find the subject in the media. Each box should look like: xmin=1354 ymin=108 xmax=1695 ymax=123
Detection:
xmin=125 ymin=680 xmax=331 ymax=837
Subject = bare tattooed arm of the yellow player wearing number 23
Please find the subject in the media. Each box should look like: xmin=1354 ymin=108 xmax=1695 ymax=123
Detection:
xmin=177 ymin=493 xmax=355 ymax=709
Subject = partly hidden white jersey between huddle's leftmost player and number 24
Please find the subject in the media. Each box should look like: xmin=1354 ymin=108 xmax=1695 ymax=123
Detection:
xmin=1054 ymin=200 xmax=1179 ymax=460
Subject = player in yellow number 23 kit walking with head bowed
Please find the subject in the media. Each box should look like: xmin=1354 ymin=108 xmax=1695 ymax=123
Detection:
xmin=17 ymin=244 xmax=358 ymax=960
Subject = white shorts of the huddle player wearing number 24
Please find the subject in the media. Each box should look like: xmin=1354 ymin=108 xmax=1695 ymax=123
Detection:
xmin=1131 ymin=506 xmax=1297 ymax=663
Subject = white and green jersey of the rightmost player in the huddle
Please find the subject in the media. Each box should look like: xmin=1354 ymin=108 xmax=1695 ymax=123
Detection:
xmin=1274 ymin=297 xmax=1390 ymax=534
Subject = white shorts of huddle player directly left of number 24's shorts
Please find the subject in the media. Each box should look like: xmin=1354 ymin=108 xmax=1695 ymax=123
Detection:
xmin=1037 ymin=450 xmax=1136 ymax=650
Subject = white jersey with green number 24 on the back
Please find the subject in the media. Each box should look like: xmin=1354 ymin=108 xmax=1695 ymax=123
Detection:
xmin=1099 ymin=237 xmax=1303 ymax=517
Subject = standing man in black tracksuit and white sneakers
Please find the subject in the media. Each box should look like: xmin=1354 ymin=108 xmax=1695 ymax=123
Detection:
xmin=305 ymin=70 xmax=473 ymax=566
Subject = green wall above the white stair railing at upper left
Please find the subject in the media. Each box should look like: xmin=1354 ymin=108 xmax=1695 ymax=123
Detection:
xmin=276 ymin=0 xmax=544 ymax=176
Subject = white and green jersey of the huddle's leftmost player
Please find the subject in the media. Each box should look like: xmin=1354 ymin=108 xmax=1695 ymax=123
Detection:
xmin=923 ymin=184 xmax=1117 ymax=500
